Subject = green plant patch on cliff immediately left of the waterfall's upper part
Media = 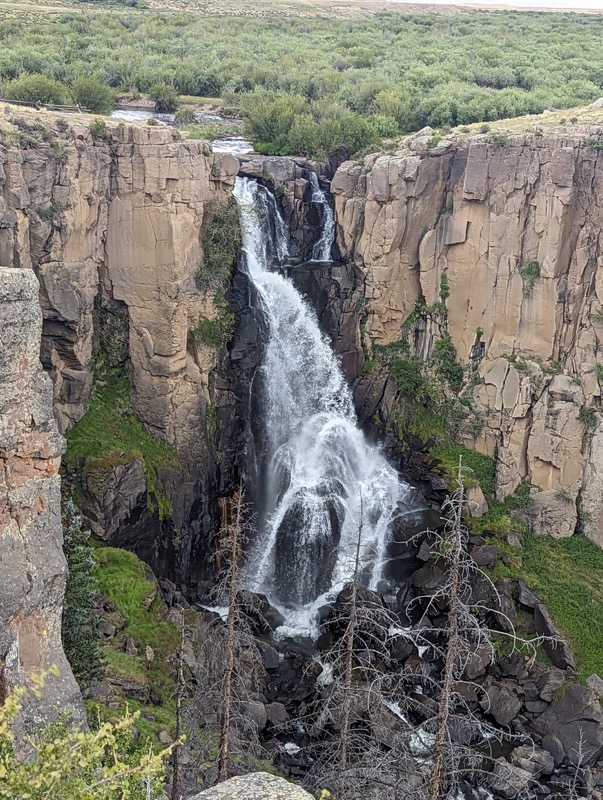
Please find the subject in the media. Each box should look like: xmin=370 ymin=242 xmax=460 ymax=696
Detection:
xmin=195 ymin=197 xmax=241 ymax=291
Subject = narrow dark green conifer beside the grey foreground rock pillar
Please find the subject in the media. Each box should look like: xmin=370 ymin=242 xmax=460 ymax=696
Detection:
xmin=61 ymin=500 xmax=105 ymax=689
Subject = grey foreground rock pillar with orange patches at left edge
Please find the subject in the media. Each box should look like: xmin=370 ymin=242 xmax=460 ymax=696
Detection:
xmin=0 ymin=267 xmax=83 ymax=730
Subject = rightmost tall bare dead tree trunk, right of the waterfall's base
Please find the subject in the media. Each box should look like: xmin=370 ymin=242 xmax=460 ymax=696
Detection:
xmin=430 ymin=482 xmax=463 ymax=800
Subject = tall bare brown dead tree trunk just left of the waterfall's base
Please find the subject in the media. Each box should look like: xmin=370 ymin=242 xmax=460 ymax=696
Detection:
xmin=218 ymin=491 xmax=242 ymax=781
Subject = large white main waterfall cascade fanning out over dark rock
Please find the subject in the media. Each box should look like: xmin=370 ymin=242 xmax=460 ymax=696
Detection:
xmin=234 ymin=178 xmax=416 ymax=631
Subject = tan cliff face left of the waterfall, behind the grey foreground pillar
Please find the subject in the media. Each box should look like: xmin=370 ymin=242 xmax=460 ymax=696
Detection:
xmin=0 ymin=112 xmax=239 ymax=579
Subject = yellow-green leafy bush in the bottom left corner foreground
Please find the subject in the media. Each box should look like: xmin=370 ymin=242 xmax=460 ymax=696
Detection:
xmin=0 ymin=669 xmax=171 ymax=800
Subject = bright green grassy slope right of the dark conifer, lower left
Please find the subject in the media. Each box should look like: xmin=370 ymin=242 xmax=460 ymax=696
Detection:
xmin=88 ymin=547 xmax=180 ymax=739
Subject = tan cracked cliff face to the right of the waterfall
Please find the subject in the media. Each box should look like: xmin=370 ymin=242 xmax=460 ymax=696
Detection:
xmin=332 ymin=130 xmax=603 ymax=545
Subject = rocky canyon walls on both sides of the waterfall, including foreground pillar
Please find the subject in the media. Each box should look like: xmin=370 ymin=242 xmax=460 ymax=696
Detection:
xmin=0 ymin=115 xmax=603 ymax=792
